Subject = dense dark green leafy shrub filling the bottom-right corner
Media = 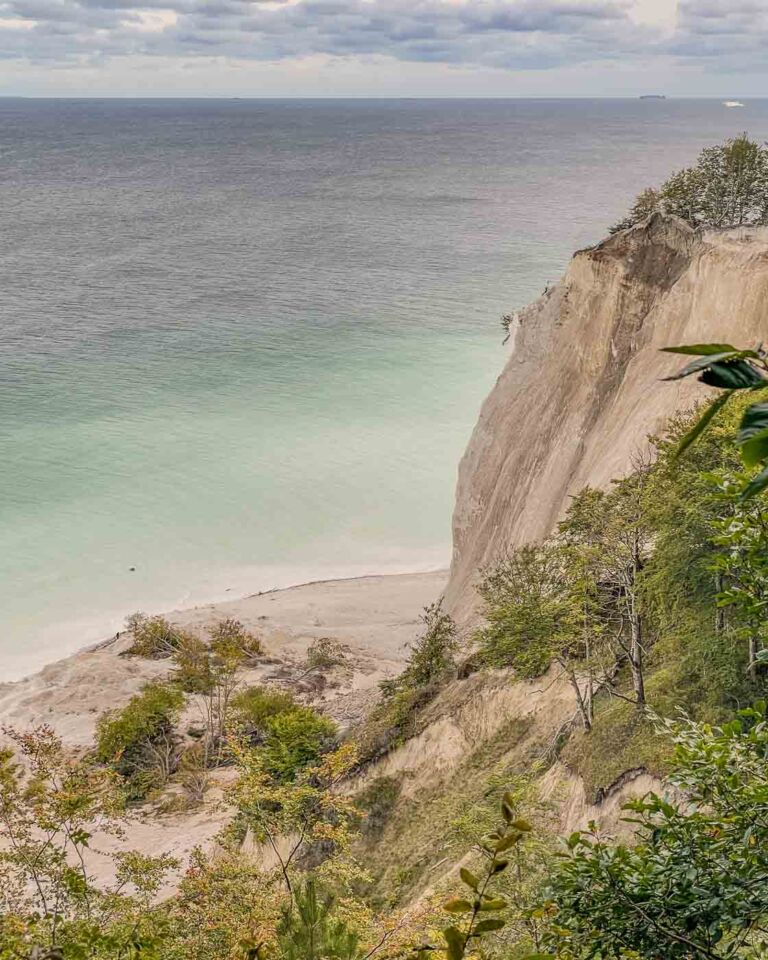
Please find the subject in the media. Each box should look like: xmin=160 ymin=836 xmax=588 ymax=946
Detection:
xmin=547 ymin=702 xmax=768 ymax=960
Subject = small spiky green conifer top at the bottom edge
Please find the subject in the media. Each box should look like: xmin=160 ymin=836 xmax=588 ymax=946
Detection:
xmin=277 ymin=878 xmax=363 ymax=960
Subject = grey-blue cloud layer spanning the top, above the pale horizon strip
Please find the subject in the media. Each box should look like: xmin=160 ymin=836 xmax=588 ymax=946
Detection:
xmin=0 ymin=0 xmax=768 ymax=79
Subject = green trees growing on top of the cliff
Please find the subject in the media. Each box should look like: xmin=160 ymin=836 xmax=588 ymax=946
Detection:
xmin=613 ymin=133 xmax=768 ymax=232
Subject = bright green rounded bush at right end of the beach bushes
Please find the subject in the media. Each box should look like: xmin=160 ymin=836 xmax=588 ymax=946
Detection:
xmin=262 ymin=707 xmax=336 ymax=783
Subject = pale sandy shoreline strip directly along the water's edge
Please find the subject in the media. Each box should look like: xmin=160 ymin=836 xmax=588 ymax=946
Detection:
xmin=0 ymin=570 xmax=448 ymax=747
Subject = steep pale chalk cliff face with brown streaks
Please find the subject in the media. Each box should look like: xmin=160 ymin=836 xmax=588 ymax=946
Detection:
xmin=446 ymin=214 xmax=768 ymax=622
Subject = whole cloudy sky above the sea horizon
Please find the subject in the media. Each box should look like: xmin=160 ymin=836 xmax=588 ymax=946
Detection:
xmin=0 ymin=0 xmax=768 ymax=97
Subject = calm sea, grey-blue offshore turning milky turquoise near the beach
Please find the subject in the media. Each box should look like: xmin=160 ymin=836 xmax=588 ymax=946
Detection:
xmin=0 ymin=99 xmax=768 ymax=679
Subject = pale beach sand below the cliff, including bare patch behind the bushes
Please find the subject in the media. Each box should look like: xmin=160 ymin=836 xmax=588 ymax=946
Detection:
xmin=0 ymin=572 xmax=447 ymax=895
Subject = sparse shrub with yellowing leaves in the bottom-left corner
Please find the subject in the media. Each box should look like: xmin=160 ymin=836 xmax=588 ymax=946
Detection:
xmin=0 ymin=726 xmax=176 ymax=960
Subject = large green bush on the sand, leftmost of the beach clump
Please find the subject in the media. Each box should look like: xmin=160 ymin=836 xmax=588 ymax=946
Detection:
xmin=95 ymin=681 xmax=184 ymax=800
